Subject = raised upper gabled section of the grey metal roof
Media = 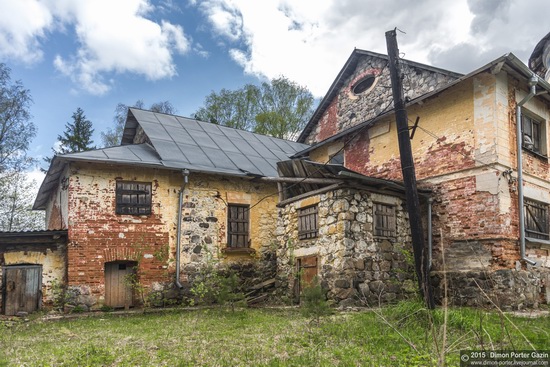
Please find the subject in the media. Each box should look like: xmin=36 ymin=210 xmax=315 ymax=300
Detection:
xmin=122 ymin=108 xmax=308 ymax=177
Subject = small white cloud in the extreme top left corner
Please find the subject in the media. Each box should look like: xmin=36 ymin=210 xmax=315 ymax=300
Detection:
xmin=0 ymin=0 xmax=53 ymax=64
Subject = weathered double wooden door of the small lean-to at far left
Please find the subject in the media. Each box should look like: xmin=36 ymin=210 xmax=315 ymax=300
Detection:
xmin=3 ymin=265 xmax=42 ymax=316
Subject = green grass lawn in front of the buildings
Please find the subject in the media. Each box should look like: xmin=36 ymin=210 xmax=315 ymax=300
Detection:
xmin=0 ymin=302 xmax=550 ymax=367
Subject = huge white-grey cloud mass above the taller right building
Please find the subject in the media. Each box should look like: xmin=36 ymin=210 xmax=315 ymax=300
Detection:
xmin=196 ymin=0 xmax=550 ymax=96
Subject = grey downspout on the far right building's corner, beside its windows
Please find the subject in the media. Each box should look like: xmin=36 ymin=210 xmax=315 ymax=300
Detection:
xmin=516 ymin=74 xmax=538 ymax=265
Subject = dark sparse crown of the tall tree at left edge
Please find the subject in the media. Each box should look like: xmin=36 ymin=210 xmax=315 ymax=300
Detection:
xmin=0 ymin=63 xmax=36 ymax=173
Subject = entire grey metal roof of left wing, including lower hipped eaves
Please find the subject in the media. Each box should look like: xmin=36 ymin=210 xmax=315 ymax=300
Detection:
xmin=33 ymin=108 xmax=308 ymax=210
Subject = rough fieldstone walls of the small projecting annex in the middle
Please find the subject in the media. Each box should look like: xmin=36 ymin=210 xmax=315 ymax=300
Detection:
xmin=276 ymin=189 xmax=416 ymax=307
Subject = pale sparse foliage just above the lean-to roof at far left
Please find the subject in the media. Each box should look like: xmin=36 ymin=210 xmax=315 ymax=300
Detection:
xmin=0 ymin=170 xmax=44 ymax=232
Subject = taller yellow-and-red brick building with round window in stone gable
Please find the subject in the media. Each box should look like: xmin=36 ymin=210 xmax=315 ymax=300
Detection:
xmin=294 ymin=50 xmax=550 ymax=307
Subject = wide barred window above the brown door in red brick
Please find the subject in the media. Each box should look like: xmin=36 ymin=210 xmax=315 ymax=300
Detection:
xmin=116 ymin=181 xmax=151 ymax=215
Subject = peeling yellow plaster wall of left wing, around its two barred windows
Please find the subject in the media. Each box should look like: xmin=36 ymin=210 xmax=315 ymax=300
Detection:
xmin=57 ymin=163 xmax=278 ymax=280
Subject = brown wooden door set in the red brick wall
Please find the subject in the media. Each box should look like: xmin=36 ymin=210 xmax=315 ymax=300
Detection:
xmin=105 ymin=261 xmax=136 ymax=308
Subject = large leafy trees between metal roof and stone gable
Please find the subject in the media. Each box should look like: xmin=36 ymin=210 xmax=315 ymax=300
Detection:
xmin=193 ymin=77 xmax=314 ymax=139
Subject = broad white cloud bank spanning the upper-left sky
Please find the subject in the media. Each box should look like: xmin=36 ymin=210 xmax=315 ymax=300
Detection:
xmin=0 ymin=0 xmax=190 ymax=94
